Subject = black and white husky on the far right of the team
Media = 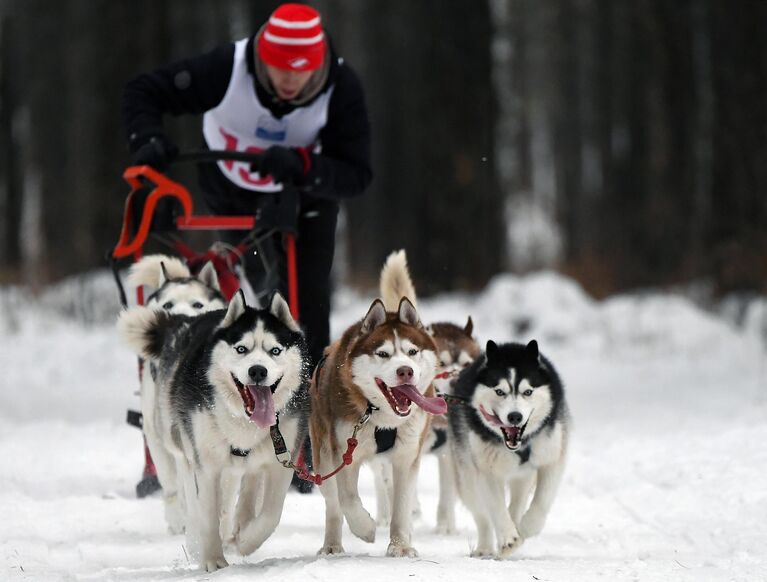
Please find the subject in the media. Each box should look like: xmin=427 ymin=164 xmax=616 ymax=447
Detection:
xmin=448 ymin=340 xmax=570 ymax=558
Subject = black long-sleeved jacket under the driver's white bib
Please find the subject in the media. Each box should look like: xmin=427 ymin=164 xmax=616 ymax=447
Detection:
xmin=122 ymin=37 xmax=373 ymax=199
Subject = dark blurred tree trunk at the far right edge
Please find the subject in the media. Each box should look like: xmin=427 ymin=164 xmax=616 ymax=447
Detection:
xmin=707 ymin=0 xmax=767 ymax=292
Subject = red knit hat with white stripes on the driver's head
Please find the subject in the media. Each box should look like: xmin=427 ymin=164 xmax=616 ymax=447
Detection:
xmin=257 ymin=4 xmax=325 ymax=71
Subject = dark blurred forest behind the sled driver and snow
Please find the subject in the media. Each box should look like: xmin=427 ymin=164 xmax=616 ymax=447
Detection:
xmin=0 ymin=0 xmax=767 ymax=296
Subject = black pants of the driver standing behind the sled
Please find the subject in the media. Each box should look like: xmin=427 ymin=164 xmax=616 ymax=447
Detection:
xmin=204 ymin=189 xmax=338 ymax=369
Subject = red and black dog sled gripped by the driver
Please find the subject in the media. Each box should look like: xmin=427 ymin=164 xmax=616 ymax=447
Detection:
xmin=108 ymin=150 xmax=306 ymax=498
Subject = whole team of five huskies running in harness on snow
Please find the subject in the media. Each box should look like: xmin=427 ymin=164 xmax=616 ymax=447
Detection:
xmin=118 ymin=251 xmax=569 ymax=572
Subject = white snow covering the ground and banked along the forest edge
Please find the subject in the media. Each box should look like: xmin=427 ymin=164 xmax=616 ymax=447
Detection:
xmin=0 ymin=273 xmax=767 ymax=582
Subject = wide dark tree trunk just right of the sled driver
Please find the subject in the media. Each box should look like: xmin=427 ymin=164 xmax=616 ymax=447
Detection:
xmin=349 ymin=2 xmax=504 ymax=294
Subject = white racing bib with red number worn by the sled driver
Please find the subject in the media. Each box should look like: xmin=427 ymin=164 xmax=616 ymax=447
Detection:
xmin=202 ymin=39 xmax=333 ymax=192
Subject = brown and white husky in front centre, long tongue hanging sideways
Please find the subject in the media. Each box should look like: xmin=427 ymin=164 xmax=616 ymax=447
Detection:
xmin=310 ymin=253 xmax=446 ymax=557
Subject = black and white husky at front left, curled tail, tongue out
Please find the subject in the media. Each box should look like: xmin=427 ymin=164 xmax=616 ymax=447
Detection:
xmin=118 ymin=292 xmax=308 ymax=572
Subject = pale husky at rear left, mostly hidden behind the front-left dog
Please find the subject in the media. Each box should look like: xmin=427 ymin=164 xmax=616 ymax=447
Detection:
xmin=128 ymin=254 xmax=226 ymax=533
